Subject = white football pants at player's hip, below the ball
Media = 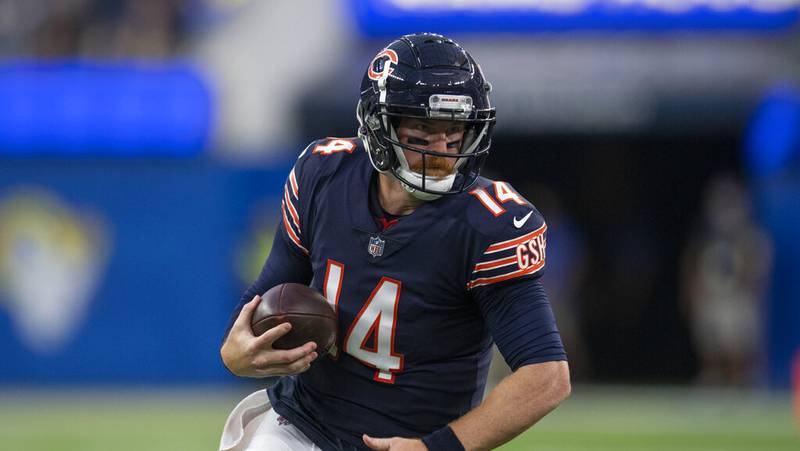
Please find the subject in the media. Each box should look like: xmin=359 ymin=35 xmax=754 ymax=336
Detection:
xmin=219 ymin=390 xmax=322 ymax=451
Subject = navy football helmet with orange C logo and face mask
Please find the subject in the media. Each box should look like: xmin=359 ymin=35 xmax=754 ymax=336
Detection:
xmin=357 ymin=33 xmax=495 ymax=200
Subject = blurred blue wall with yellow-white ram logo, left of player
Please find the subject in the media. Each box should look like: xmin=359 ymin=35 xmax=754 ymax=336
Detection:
xmin=0 ymin=159 xmax=288 ymax=384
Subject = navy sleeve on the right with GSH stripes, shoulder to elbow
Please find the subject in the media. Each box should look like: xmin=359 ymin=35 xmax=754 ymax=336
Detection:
xmin=466 ymin=182 xmax=566 ymax=370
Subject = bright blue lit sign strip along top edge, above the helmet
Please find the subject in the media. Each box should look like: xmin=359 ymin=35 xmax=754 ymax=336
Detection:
xmin=351 ymin=0 xmax=800 ymax=36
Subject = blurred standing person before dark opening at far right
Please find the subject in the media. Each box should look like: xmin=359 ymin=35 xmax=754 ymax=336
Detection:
xmin=681 ymin=176 xmax=772 ymax=385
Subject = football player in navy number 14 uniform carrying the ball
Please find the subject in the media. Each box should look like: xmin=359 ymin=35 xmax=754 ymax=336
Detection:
xmin=220 ymin=33 xmax=570 ymax=451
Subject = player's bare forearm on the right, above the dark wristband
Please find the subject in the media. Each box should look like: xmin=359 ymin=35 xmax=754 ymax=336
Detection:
xmin=450 ymin=361 xmax=570 ymax=451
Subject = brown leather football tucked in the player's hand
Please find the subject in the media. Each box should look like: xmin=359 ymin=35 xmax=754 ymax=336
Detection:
xmin=250 ymin=283 xmax=338 ymax=356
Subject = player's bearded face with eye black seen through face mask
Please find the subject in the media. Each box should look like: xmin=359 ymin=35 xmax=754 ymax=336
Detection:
xmin=397 ymin=118 xmax=464 ymax=177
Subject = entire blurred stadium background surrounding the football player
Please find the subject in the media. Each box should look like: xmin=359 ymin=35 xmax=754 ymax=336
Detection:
xmin=0 ymin=0 xmax=800 ymax=451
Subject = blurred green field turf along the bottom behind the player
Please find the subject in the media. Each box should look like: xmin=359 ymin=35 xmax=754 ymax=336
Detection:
xmin=0 ymin=386 xmax=800 ymax=451
